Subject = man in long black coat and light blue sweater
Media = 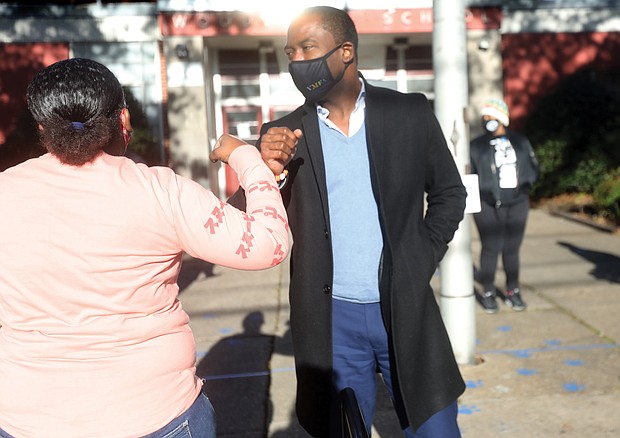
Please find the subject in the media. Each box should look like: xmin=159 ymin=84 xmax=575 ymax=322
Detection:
xmin=229 ymin=7 xmax=466 ymax=438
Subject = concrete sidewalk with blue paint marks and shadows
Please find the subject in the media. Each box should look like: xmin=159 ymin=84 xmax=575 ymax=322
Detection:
xmin=180 ymin=210 xmax=620 ymax=438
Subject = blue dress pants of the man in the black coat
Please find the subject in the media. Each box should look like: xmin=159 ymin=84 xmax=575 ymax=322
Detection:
xmin=332 ymin=299 xmax=461 ymax=438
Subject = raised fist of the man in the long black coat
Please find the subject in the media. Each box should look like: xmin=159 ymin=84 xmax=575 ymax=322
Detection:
xmin=260 ymin=127 xmax=303 ymax=175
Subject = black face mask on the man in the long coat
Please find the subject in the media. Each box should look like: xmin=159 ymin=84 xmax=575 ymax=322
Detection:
xmin=288 ymin=44 xmax=353 ymax=103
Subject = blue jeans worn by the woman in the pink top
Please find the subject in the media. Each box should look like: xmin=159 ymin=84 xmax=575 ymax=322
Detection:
xmin=0 ymin=393 xmax=215 ymax=438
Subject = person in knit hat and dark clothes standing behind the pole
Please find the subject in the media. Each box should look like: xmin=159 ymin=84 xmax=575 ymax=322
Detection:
xmin=470 ymin=99 xmax=539 ymax=313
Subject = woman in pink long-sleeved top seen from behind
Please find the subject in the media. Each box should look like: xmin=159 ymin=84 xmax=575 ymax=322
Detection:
xmin=0 ymin=59 xmax=289 ymax=438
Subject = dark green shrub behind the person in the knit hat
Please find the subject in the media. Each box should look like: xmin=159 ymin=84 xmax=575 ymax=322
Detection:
xmin=524 ymin=71 xmax=620 ymax=205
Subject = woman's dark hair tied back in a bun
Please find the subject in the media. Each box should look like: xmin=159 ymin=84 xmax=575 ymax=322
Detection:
xmin=26 ymin=58 xmax=125 ymax=166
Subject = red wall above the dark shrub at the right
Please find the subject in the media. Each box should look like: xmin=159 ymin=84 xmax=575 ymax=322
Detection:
xmin=502 ymin=32 xmax=620 ymax=128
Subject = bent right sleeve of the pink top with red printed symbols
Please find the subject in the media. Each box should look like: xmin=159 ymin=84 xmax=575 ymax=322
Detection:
xmin=170 ymin=145 xmax=289 ymax=270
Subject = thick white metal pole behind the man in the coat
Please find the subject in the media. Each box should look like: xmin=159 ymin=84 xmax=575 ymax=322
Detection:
xmin=433 ymin=0 xmax=476 ymax=364
